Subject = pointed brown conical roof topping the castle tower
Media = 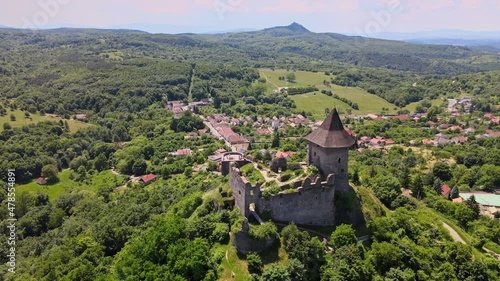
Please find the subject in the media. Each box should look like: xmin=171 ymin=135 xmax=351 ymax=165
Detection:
xmin=306 ymin=108 xmax=356 ymax=148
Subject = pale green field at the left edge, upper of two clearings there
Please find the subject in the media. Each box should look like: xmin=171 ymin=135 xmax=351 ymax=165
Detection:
xmin=0 ymin=110 xmax=91 ymax=133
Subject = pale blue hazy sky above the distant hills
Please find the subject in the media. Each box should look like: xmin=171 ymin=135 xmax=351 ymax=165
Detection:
xmin=0 ymin=0 xmax=500 ymax=34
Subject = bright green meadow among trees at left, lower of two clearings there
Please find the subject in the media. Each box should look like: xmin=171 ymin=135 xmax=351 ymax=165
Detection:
xmin=16 ymin=170 xmax=125 ymax=201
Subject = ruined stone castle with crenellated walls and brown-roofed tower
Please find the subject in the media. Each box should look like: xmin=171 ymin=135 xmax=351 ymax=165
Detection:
xmin=229 ymin=109 xmax=355 ymax=226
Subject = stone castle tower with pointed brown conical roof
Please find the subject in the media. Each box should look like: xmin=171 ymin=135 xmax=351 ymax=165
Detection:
xmin=306 ymin=108 xmax=356 ymax=191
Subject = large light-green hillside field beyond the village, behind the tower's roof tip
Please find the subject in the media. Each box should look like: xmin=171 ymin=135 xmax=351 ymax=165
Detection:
xmin=260 ymin=69 xmax=397 ymax=117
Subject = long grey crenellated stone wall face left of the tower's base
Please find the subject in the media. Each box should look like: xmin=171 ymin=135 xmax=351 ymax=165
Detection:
xmin=256 ymin=175 xmax=335 ymax=225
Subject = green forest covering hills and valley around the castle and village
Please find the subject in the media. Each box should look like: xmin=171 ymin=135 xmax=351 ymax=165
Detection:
xmin=0 ymin=25 xmax=500 ymax=281
